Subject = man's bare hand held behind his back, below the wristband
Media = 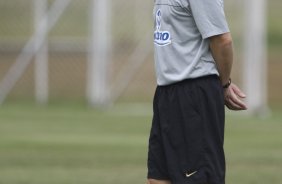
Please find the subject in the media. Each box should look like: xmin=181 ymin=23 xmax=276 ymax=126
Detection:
xmin=224 ymin=83 xmax=247 ymax=111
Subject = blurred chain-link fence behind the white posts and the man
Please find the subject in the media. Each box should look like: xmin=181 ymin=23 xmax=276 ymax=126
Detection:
xmin=0 ymin=0 xmax=282 ymax=105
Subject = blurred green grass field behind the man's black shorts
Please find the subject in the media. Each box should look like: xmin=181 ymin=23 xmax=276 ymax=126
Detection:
xmin=0 ymin=103 xmax=282 ymax=184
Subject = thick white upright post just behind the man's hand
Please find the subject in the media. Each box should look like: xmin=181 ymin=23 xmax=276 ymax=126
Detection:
xmin=244 ymin=0 xmax=268 ymax=115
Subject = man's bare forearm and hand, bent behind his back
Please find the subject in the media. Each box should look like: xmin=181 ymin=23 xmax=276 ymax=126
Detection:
xmin=209 ymin=33 xmax=247 ymax=110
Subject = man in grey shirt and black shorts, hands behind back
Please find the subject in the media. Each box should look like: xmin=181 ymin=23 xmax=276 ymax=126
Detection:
xmin=148 ymin=0 xmax=247 ymax=184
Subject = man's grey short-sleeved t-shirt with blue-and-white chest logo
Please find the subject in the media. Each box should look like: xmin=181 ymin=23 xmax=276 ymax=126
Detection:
xmin=154 ymin=0 xmax=229 ymax=85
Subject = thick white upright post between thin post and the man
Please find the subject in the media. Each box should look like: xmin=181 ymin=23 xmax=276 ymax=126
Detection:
xmin=87 ymin=0 xmax=111 ymax=108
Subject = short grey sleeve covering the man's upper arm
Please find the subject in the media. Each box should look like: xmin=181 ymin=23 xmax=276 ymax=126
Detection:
xmin=188 ymin=0 xmax=230 ymax=39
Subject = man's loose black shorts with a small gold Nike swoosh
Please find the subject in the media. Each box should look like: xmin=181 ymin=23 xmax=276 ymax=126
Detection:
xmin=148 ymin=75 xmax=225 ymax=184
